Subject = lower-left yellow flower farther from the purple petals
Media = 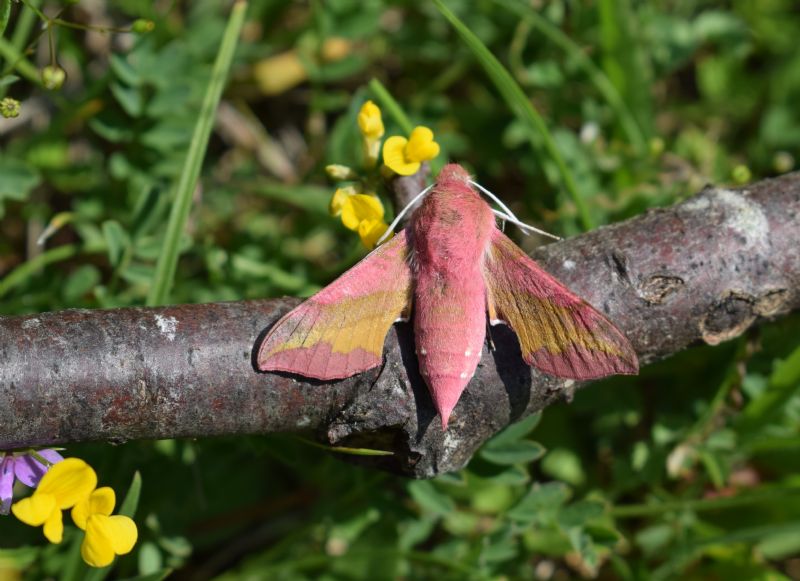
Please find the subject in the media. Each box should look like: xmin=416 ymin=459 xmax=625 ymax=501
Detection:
xmin=72 ymin=486 xmax=139 ymax=567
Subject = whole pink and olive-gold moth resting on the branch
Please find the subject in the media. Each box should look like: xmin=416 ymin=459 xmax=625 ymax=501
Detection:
xmin=257 ymin=164 xmax=638 ymax=429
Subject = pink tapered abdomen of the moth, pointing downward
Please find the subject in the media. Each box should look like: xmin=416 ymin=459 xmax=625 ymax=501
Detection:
xmin=414 ymin=268 xmax=486 ymax=427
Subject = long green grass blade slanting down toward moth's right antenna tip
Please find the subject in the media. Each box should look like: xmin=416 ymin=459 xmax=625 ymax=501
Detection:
xmin=433 ymin=0 xmax=594 ymax=230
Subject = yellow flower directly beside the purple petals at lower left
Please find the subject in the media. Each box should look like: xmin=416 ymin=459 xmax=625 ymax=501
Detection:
xmin=11 ymin=458 xmax=97 ymax=543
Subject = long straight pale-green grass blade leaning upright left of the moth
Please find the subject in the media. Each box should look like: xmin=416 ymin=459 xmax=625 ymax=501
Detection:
xmin=147 ymin=0 xmax=247 ymax=306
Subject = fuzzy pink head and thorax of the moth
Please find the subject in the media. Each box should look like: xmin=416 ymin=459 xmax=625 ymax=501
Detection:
xmin=411 ymin=166 xmax=495 ymax=274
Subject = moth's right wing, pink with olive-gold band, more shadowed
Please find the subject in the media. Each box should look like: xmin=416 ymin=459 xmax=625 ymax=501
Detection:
xmin=484 ymin=230 xmax=639 ymax=379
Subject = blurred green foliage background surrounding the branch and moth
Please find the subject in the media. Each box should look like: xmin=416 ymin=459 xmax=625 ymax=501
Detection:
xmin=0 ymin=0 xmax=800 ymax=581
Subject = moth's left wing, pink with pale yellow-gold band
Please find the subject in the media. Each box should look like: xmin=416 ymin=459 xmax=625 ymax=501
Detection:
xmin=257 ymin=231 xmax=412 ymax=379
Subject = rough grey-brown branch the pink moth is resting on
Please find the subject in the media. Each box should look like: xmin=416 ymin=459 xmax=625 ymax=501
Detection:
xmin=0 ymin=173 xmax=800 ymax=477
